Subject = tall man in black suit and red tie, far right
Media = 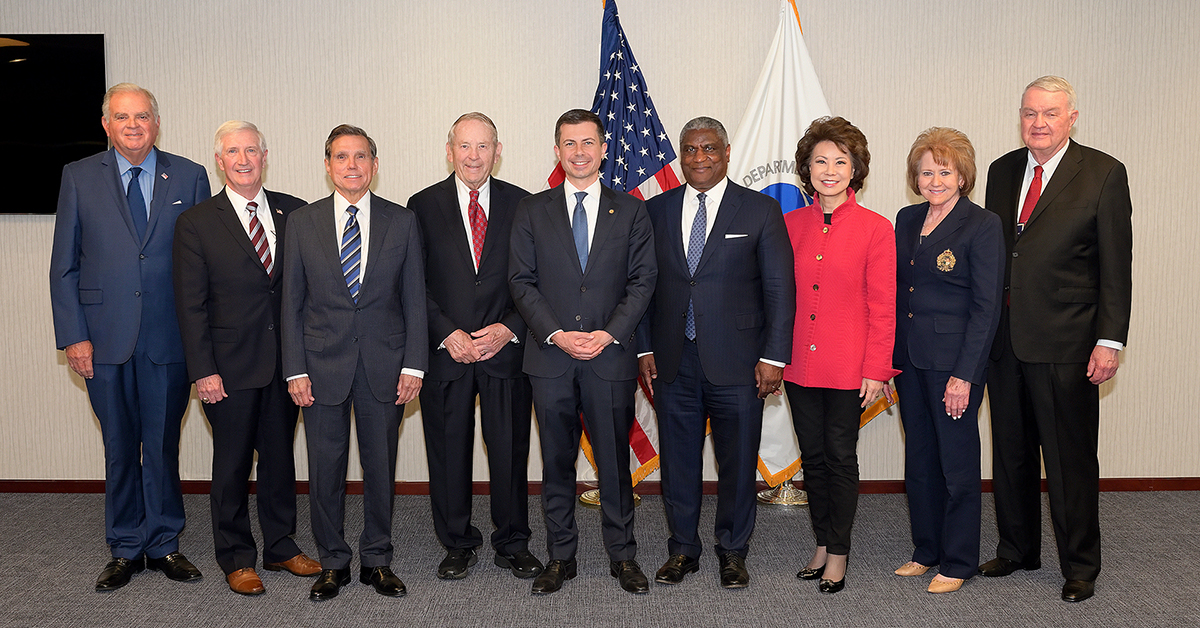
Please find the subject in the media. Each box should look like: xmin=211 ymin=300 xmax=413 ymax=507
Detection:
xmin=979 ymin=77 xmax=1133 ymax=602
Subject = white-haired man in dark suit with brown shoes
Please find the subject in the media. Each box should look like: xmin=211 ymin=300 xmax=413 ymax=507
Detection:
xmin=174 ymin=120 xmax=320 ymax=596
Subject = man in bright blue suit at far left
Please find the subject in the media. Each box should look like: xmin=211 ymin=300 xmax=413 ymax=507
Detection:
xmin=50 ymin=83 xmax=210 ymax=591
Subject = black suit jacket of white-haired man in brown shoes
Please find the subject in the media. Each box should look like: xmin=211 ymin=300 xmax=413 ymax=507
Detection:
xmin=174 ymin=189 xmax=305 ymax=390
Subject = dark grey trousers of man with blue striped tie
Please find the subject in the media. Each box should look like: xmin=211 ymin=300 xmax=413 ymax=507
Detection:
xmin=304 ymin=357 xmax=404 ymax=569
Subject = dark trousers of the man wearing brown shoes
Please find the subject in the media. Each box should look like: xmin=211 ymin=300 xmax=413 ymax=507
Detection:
xmin=203 ymin=372 xmax=300 ymax=574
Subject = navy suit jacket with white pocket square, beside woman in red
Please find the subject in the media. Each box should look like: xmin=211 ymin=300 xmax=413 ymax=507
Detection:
xmin=637 ymin=181 xmax=796 ymax=385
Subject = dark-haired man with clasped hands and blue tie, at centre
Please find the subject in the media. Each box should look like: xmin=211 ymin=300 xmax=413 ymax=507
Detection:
xmin=509 ymin=109 xmax=658 ymax=594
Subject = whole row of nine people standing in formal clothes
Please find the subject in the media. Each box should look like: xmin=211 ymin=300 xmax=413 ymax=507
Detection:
xmin=50 ymin=77 xmax=1132 ymax=609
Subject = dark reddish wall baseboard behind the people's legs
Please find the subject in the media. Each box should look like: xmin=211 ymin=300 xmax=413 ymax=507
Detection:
xmin=0 ymin=478 xmax=1200 ymax=495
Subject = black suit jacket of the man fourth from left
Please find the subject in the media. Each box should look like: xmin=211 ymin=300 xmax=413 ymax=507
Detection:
xmin=408 ymin=174 xmax=529 ymax=381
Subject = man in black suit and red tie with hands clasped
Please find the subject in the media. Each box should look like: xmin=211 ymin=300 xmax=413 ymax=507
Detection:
xmin=408 ymin=112 xmax=541 ymax=580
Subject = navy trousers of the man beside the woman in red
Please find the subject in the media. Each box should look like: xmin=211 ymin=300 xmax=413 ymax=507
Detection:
xmin=654 ymin=342 xmax=762 ymax=558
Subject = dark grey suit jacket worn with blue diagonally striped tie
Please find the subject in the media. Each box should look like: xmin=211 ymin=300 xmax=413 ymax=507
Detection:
xmin=283 ymin=195 xmax=428 ymax=406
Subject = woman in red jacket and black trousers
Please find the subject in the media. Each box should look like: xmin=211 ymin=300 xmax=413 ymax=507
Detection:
xmin=784 ymin=118 xmax=899 ymax=593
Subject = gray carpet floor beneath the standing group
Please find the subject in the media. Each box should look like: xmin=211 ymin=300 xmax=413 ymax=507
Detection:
xmin=0 ymin=492 xmax=1200 ymax=628
